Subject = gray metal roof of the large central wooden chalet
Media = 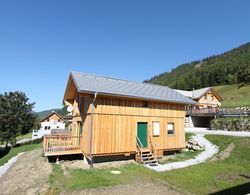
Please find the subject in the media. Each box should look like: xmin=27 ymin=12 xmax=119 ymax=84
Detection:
xmin=70 ymin=72 xmax=195 ymax=104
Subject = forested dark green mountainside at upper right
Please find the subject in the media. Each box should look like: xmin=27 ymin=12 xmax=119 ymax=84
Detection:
xmin=144 ymin=43 xmax=250 ymax=90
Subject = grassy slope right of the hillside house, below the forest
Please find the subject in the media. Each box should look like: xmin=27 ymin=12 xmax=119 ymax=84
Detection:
xmin=213 ymin=85 xmax=250 ymax=108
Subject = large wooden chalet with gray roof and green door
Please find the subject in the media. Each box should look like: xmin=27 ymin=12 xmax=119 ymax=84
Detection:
xmin=44 ymin=72 xmax=195 ymax=163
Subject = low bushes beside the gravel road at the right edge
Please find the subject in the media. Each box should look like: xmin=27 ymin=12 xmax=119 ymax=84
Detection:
xmin=210 ymin=118 xmax=250 ymax=131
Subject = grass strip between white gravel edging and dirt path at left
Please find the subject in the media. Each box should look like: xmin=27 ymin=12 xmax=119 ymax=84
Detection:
xmin=0 ymin=143 xmax=42 ymax=166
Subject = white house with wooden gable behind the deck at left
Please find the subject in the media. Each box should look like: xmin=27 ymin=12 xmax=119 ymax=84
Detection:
xmin=32 ymin=111 xmax=65 ymax=139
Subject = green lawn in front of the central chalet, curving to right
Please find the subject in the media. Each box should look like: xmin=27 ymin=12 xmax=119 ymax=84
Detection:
xmin=46 ymin=135 xmax=250 ymax=194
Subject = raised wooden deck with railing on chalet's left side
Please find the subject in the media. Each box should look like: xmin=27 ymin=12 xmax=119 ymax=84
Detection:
xmin=43 ymin=135 xmax=82 ymax=156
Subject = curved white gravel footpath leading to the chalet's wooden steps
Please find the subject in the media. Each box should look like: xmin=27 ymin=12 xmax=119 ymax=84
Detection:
xmin=145 ymin=134 xmax=218 ymax=172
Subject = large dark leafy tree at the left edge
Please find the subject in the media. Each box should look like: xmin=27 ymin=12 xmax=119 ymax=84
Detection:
xmin=0 ymin=91 xmax=36 ymax=146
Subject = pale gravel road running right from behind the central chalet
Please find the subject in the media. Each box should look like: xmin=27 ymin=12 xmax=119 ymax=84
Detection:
xmin=185 ymin=128 xmax=250 ymax=137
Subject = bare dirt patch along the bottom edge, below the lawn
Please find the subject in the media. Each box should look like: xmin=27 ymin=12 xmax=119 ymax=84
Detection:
xmin=61 ymin=181 xmax=180 ymax=195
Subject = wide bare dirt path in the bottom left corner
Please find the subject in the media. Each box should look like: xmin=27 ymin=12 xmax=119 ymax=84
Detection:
xmin=0 ymin=149 xmax=52 ymax=195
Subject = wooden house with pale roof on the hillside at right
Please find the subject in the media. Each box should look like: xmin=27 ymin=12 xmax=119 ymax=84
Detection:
xmin=175 ymin=87 xmax=222 ymax=109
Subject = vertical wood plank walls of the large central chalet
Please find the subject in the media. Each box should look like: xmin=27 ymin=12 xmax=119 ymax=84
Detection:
xmin=72 ymin=94 xmax=185 ymax=155
